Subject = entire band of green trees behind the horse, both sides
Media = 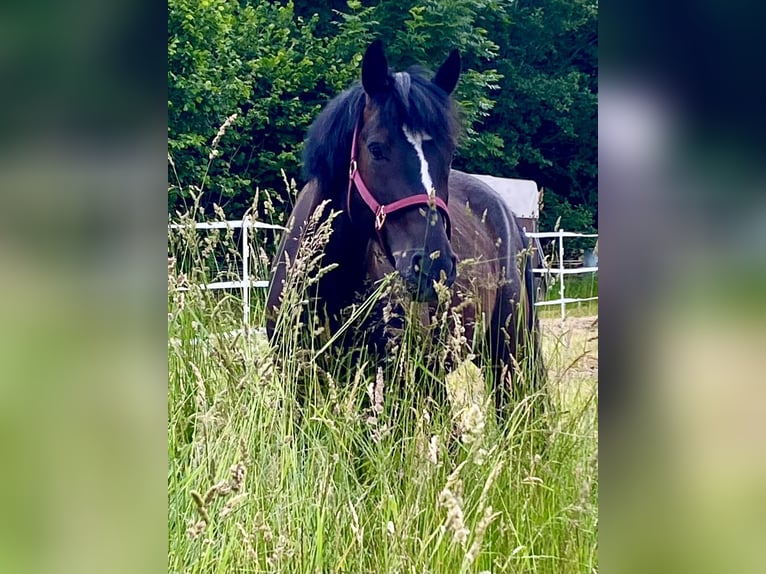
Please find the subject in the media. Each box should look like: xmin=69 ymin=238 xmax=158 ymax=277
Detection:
xmin=168 ymin=0 xmax=597 ymax=234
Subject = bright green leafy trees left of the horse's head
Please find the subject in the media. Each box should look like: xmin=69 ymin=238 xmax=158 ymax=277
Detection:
xmin=168 ymin=0 xmax=364 ymax=219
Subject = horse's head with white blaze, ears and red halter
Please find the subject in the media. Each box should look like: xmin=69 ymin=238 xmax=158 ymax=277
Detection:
xmin=346 ymin=40 xmax=460 ymax=301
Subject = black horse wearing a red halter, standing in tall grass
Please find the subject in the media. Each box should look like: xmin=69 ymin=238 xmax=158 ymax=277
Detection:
xmin=266 ymin=40 xmax=544 ymax=418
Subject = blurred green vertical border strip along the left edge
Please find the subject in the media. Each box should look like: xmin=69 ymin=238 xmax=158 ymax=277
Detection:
xmin=0 ymin=0 xmax=167 ymax=572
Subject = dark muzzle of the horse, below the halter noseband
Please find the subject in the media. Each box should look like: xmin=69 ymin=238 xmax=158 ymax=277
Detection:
xmin=396 ymin=249 xmax=457 ymax=302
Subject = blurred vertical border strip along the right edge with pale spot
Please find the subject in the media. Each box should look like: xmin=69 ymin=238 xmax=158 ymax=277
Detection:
xmin=599 ymin=1 xmax=766 ymax=572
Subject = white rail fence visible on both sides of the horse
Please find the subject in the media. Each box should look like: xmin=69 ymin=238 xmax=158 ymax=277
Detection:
xmin=170 ymin=217 xmax=598 ymax=326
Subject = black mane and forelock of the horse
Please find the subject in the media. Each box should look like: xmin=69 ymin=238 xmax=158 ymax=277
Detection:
xmin=303 ymin=67 xmax=459 ymax=194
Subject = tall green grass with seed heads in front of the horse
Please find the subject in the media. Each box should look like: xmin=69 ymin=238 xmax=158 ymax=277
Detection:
xmin=168 ymin=136 xmax=598 ymax=573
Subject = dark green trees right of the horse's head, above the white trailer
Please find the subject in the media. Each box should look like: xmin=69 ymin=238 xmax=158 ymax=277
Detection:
xmin=462 ymin=0 xmax=598 ymax=227
